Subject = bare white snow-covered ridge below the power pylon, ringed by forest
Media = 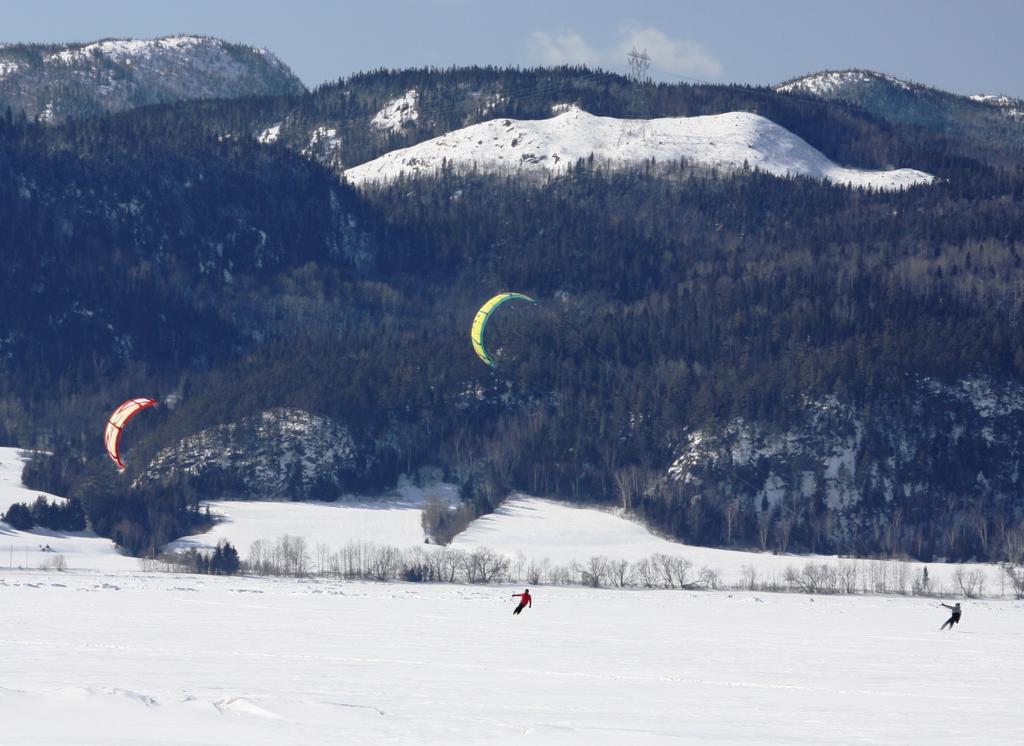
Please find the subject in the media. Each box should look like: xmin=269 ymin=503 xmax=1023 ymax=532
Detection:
xmin=345 ymin=106 xmax=932 ymax=189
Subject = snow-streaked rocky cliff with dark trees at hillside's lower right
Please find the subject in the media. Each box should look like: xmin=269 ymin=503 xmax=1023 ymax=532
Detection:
xmin=667 ymin=378 xmax=1024 ymax=552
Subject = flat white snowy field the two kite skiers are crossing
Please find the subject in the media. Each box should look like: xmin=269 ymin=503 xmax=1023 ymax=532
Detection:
xmin=0 ymin=570 xmax=1024 ymax=746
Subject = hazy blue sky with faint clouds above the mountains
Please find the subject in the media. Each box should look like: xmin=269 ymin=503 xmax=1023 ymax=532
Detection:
xmin=8 ymin=0 xmax=1024 ymax=97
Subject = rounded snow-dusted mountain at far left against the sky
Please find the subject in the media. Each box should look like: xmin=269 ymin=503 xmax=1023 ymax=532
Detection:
xmin=0 ymin=36 xmax=305 ymax=121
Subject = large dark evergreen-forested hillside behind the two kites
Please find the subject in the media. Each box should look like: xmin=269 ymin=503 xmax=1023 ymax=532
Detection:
xmin=0 ymin=69 xmax=1024 ymax=559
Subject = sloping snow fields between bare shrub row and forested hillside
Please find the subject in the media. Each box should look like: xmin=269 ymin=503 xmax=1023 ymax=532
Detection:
xmin=0 ymin=448 xmax=1012 ymax=597
